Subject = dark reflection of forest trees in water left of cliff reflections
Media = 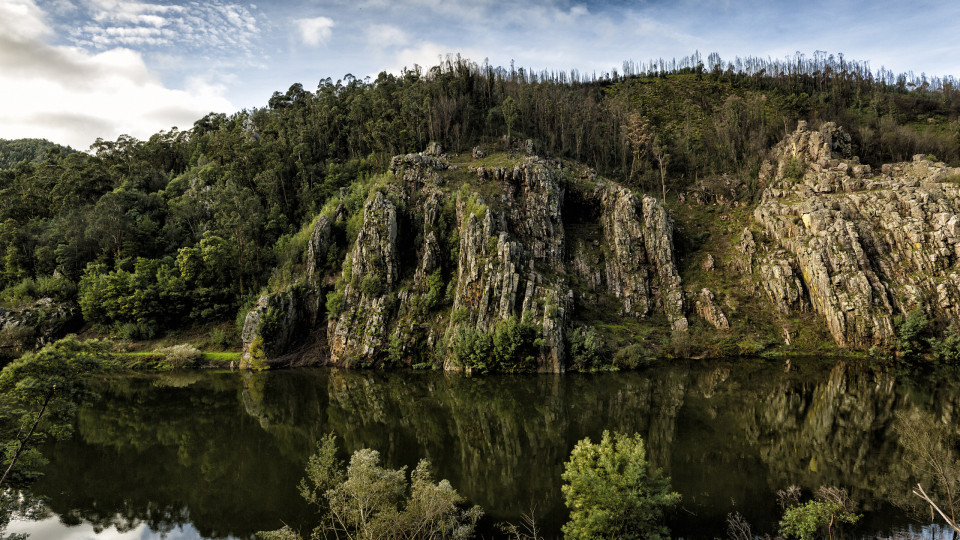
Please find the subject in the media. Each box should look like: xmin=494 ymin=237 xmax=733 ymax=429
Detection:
xmin=30 ymin=374 xmax=314 ymax=538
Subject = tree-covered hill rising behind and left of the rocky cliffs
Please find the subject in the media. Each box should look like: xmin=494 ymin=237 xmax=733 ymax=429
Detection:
xmin=0 ymin=55 xmax=960 ymax=362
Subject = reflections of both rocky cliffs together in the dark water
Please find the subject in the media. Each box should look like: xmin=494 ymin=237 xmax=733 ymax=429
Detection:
xmin=316 ymin=364 xmax=956 ymax=534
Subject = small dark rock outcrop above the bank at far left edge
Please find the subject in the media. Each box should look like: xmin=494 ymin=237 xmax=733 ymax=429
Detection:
xmin=0 ymin=298 xmax=80 ymax=357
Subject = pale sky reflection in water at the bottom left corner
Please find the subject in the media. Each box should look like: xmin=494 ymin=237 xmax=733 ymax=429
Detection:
xmin=4 ymin=516 xmax=210 ymax=540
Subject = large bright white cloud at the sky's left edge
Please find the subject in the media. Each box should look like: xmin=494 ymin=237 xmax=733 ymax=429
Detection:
xmin=0 ymin=0 xmax=236 ymax=149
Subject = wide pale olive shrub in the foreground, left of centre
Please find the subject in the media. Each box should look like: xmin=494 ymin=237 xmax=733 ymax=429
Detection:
xmin=257 ymin=434 xmax=483 ymax=540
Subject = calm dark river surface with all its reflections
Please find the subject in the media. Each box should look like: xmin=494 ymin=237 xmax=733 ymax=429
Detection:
xmin=8 ymin=361 xmax=960 ymax=538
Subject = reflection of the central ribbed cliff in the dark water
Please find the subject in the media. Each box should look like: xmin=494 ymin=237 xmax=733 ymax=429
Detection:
xmin=320 ymin=372 xmax=683 ymax=519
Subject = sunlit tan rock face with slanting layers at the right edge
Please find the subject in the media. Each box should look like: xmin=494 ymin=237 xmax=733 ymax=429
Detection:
xmin=747 ymin=123 xmax=960 ymax=348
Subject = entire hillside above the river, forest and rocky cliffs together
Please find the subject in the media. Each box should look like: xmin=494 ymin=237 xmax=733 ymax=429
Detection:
xmin=0 ymin=59 xmax=960 ymax=371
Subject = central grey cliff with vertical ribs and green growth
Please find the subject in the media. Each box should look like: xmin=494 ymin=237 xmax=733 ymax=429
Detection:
xmin=243 ymin=145 xmax=687 ymax=372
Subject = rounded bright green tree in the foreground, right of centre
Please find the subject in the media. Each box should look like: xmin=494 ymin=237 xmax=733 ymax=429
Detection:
xmin=561 ymin=431 xmax=680 ymax=539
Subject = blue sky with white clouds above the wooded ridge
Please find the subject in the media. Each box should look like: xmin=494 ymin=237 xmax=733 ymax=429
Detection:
xmin=0 ymin=0 xmax=960 ymax=150
